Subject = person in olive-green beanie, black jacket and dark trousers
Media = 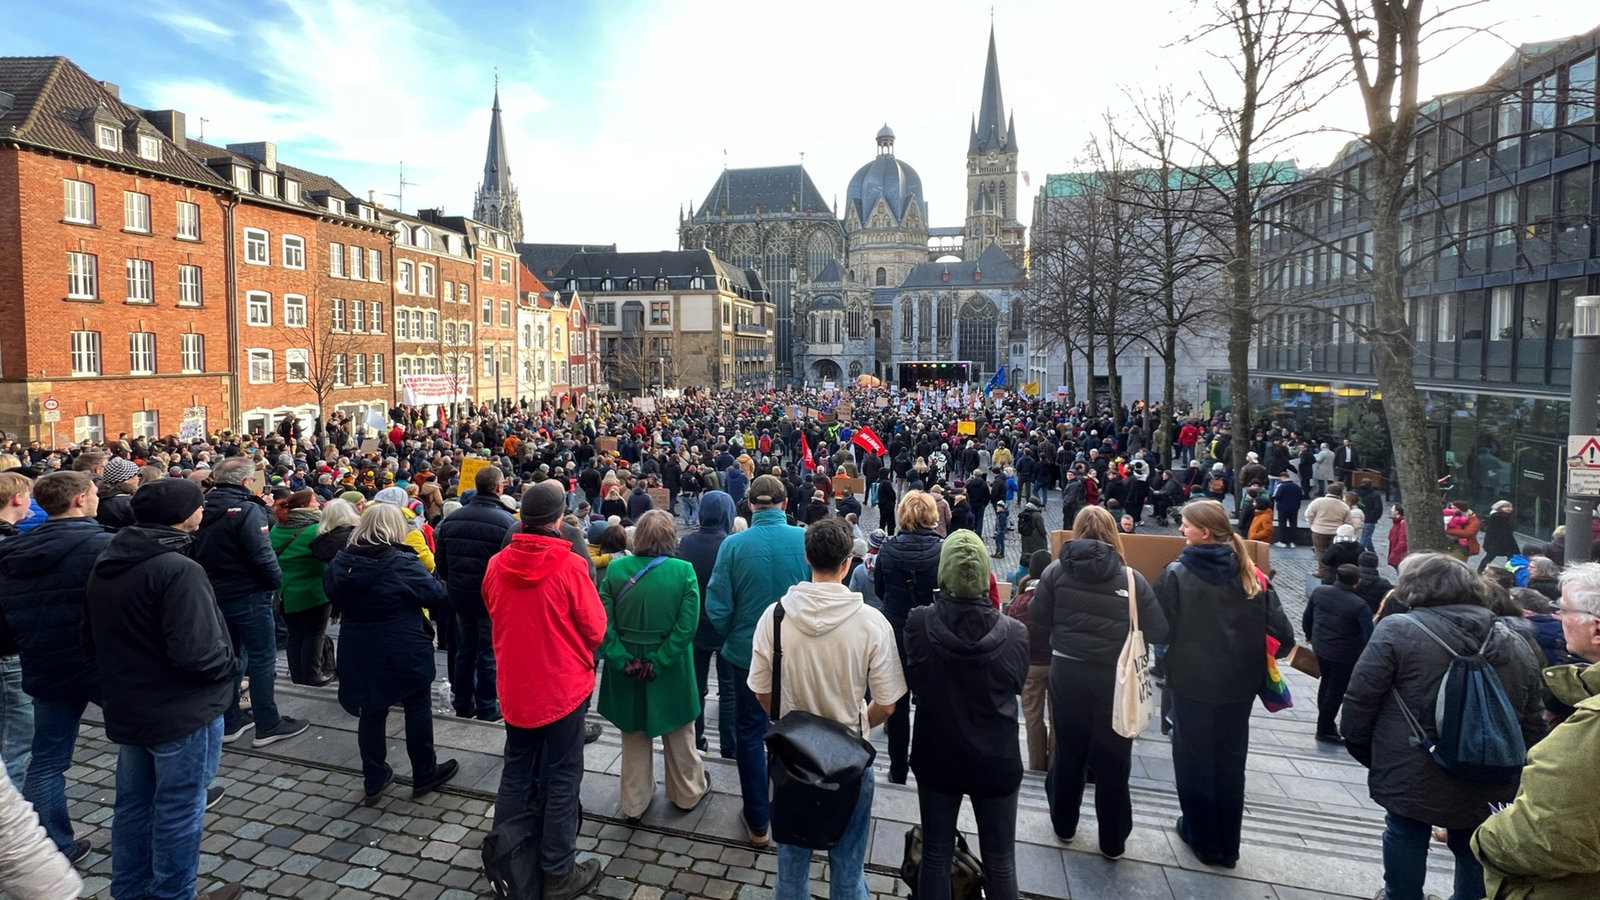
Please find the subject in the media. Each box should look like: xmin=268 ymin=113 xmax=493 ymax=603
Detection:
xmin=906 ymin=532 xmax=1027 ymax=900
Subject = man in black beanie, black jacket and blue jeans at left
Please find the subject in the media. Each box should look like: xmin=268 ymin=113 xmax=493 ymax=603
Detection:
xmin=86 ymin=479 xmax=238 ymax=900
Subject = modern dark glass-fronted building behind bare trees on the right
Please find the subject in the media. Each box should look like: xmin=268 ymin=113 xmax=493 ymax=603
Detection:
xmin=1253 ymin=29 xmax=1600 ymax=536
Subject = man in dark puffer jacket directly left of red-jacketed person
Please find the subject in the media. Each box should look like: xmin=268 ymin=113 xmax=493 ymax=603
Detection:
xmin=434 ymin=466 xmax=515 ymax=722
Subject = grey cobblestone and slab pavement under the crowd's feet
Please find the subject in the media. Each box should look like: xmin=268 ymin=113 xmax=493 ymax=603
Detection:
xmin=40 ymin=490 xmax=1450 ymax=900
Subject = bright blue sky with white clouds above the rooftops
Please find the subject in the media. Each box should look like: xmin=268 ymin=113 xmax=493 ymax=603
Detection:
xmin=12 ymin=0 xmax=1600 ymax=250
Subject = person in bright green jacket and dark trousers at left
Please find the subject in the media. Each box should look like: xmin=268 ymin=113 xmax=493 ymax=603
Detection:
xmin=267 ymin=488 xmax=333 ymax=685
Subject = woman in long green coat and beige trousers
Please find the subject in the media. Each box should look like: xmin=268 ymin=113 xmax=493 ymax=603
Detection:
xmin=600 ymin=509 xmax=710 ymax=825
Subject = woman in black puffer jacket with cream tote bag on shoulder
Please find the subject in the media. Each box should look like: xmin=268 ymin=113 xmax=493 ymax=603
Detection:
xmin=1030 ymin=506 xmax=1166 ymax=860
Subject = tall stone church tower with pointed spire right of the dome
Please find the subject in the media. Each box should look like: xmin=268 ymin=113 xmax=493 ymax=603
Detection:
xmin=962 ymin=22 xmax=1022 ymax=266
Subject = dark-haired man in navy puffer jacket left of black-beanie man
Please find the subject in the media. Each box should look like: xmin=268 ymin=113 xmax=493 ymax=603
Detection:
xmin=0 ymin=472 xmax=110 ymax=863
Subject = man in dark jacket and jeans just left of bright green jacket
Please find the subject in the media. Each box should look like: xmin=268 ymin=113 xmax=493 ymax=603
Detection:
xmin=194 ymin=456 xmax=310 ymax=746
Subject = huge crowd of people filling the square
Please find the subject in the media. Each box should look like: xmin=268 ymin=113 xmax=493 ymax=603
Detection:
xmin=0 ymin=381 xmax=1600 ymax=900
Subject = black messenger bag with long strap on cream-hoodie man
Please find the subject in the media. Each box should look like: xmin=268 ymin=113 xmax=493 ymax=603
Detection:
xmin=766 ymin=601 xmax=877 ymax=850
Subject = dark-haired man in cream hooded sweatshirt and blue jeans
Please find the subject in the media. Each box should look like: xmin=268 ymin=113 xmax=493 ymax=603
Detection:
xmin=747 ymin=516 xmax=906 ymax=900
